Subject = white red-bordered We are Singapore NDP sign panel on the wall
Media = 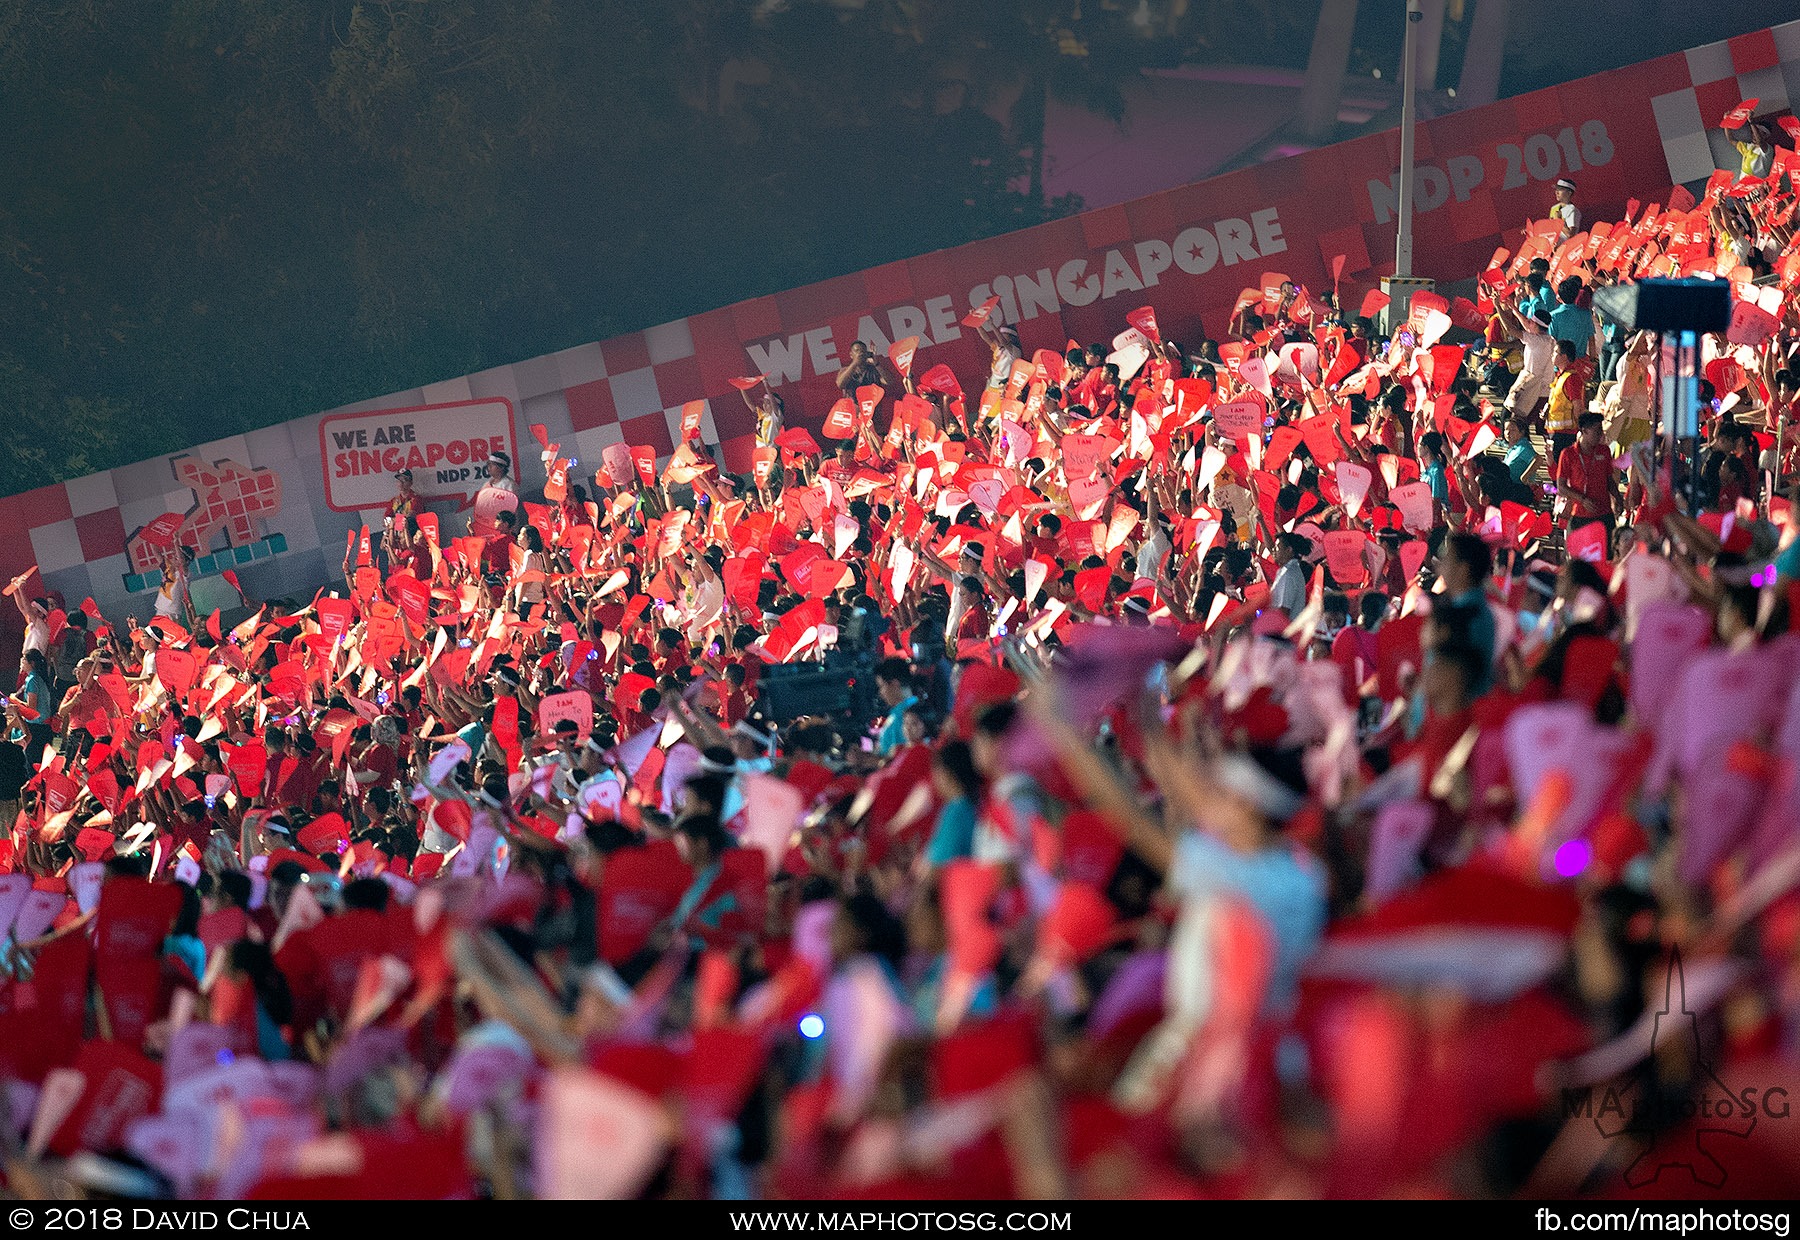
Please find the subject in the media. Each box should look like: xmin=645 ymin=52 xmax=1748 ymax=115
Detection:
xmin=319 ymin=396 xmax=518 ymax=513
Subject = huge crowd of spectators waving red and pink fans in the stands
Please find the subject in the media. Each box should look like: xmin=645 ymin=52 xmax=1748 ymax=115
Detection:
xmin=0 ymin=128 xmax=1800 ymax=1199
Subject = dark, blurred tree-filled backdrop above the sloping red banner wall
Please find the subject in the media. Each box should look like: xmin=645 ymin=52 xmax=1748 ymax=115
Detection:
xmin=0 ymin=0 xmax=1793 ymax=493
